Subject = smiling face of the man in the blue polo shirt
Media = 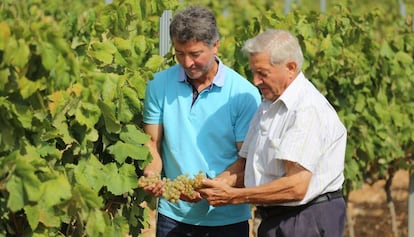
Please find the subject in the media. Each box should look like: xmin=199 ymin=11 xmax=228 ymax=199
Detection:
xmin=173 ymin=39 xmax=218 ymax=80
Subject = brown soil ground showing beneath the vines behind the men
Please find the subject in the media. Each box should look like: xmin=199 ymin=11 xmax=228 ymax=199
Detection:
xmin=142 ymin=171 xmax=409 ymax=237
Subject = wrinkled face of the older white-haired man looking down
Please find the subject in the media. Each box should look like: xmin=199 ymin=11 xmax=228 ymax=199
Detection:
xmin=249 ymin=53 xmax=297 ymax=101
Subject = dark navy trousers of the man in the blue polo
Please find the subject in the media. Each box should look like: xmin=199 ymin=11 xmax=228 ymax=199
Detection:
xmin=156 ymin=214 xmax=249 ymax=237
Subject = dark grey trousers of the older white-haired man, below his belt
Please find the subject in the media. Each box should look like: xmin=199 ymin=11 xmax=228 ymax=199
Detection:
xmin=258 ymin=198 xmax=346 ymax=237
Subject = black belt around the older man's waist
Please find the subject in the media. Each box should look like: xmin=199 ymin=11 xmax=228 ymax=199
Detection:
xmin=257 ymin=190 xmax=342 ymax=219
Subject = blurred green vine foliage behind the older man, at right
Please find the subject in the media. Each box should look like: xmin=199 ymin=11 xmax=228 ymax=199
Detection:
xmin=226 ymin=5 xmax=414 ymax=192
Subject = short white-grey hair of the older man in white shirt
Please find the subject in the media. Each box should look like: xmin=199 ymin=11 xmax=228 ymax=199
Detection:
xmin=242 ymin=29 xmax=303 ymax=71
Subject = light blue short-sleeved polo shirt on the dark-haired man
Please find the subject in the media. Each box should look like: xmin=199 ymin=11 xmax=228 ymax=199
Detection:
xmin=144 ymin=58 xmax=261 ymax=226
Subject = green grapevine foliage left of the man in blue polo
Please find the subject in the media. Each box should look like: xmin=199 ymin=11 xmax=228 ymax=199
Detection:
xmin=0 ymin=0 xmax=175 ymax=236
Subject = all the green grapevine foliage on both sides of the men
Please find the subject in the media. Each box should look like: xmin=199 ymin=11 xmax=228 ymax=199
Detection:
xmin=0 ymin=0 xmax=414 ymax=236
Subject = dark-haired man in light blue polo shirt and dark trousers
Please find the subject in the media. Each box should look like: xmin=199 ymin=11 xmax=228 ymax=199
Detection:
xmin=144 ymin=4 xmax=261 ymax=237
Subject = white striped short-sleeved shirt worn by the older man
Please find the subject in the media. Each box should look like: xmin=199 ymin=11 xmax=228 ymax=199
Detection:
xmin=239 ymin=73 xmax=347 ymax=206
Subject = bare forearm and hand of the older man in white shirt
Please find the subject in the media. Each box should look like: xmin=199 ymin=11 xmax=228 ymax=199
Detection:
xmin=200 ymin=161 xmax=312 ymax=206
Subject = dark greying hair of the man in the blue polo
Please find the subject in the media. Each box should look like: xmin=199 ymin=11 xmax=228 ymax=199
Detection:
xmin=170 ymin=6 xmax=219 ymax=47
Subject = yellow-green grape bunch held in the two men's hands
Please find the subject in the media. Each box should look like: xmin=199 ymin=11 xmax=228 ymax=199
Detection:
xmin=138 ymin=171 xmax=205 ymax=203
